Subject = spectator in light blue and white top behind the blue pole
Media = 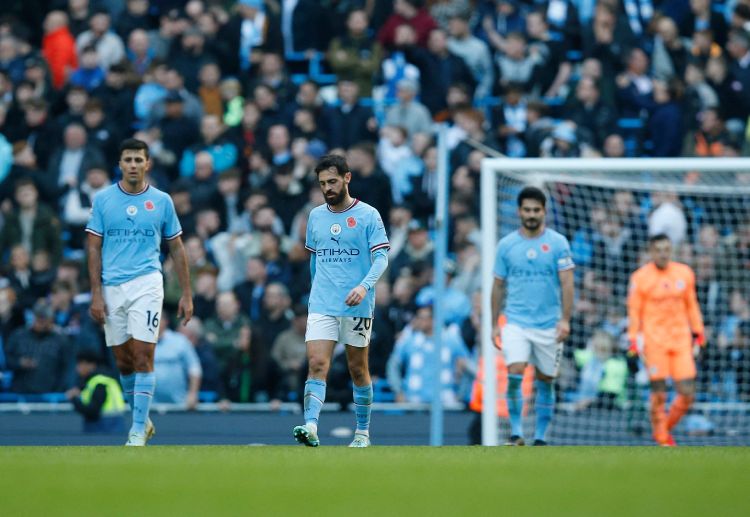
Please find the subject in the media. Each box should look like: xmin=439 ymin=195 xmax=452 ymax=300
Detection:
xmin=388 ymin=306 xmax=469 ymax=404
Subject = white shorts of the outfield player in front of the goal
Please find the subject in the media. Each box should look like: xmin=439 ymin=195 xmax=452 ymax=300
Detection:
xmin=501 ymin=323 xmax=563 ymax=377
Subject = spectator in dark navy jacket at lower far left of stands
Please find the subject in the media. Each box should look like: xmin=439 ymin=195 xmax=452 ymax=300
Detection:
xmin=4 ymin=300 xmax=73 ymax=393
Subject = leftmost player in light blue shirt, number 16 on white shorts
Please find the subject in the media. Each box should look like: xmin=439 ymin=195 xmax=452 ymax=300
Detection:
xmin=86 ymin=139 xmax=193 ymax=446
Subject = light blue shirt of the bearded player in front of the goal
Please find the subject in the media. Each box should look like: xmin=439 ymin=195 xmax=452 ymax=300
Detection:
xmin=494 ymin=228 xmax=575 ymax=329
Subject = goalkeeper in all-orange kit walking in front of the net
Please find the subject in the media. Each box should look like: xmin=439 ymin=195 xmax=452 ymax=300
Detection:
xmin=628 ymin=234 xmax=706 ymax=446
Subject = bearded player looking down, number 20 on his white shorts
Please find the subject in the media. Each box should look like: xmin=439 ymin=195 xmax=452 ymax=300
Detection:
xmin=293 ymin=155 xmax=390 ymax=447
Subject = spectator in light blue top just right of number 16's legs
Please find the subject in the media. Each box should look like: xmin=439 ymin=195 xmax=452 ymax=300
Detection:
xmin=154 ymin=314 xmax=203 ymax=409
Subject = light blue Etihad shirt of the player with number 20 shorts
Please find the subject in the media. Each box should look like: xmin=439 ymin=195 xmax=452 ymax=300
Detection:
xmin=305 ymin=199 xmax=390 ymax=318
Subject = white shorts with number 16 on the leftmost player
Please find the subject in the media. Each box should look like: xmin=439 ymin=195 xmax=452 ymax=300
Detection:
xmin=102 ymin=271 xmax=164 ymax=346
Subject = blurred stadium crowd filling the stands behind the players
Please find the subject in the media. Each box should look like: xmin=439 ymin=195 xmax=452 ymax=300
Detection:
xmin=0 ymin=0 xmax=750 ymax=412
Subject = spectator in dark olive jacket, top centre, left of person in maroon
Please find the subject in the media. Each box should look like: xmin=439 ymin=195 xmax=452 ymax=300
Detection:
xmin=326 ymin=9 xmax=383 ymax=97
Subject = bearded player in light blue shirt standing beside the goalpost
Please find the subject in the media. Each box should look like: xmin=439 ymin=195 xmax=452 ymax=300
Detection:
xmin=492 ymin=187 xmax=575 ymax=445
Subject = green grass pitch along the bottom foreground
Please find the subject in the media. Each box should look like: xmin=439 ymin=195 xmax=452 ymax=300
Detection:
xmin=0 ymin=446 xmax=750 ymax=517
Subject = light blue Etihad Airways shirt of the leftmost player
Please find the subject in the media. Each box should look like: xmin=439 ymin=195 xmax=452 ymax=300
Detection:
xmin=86 ymin=182 xmax=182 ymax=285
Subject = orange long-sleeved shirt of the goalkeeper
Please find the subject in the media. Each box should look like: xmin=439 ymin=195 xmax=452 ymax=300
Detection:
xmin=628 ymin=262 xmax=703 ymax=349
